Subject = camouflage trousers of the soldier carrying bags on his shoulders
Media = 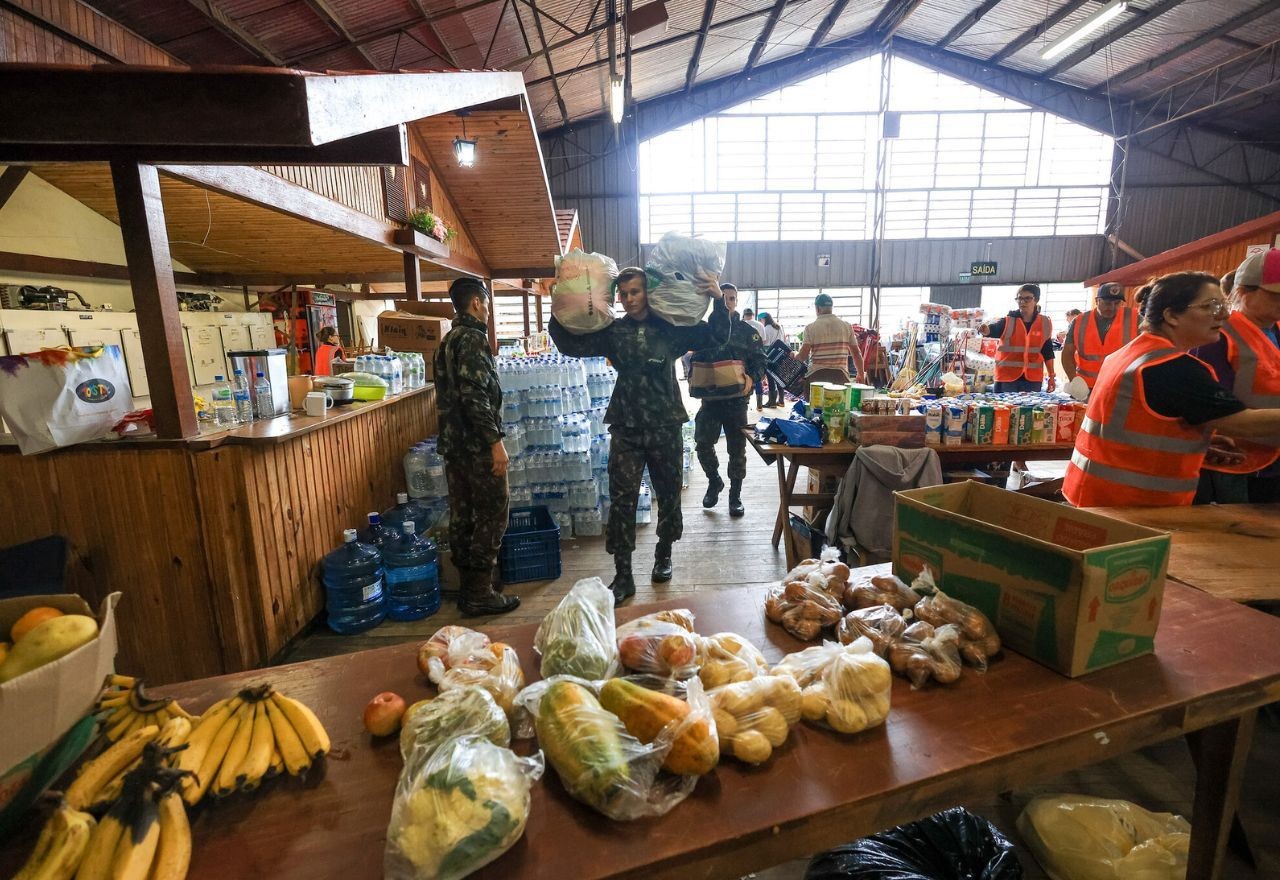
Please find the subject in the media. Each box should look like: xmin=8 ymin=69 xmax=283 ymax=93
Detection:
xmin=604 ymin=425 xmax=685 ymax=555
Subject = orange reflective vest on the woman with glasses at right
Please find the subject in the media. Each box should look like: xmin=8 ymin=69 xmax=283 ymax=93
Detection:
xmin=1062 ymin=333 xmax=1213 ymax=508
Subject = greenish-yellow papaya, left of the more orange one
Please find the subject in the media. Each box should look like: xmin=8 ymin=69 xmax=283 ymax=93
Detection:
xmin=534 ymin=682 xmax=631 ymax=815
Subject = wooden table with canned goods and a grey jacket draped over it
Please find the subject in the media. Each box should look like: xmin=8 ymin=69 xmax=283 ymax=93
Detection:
xmin=742 ymin=427 xmax=1075 ymax=568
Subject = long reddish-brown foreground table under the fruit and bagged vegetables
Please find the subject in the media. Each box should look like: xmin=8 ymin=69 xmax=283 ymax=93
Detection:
xmin=0 ymin=578 xmax=1280 ymax=880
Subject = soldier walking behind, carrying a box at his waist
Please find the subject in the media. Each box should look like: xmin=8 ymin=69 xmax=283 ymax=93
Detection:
xmin=689 ymin=284 xmax=765 ymax=517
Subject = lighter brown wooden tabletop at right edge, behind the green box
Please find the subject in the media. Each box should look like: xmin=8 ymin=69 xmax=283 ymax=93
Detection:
xmin=1089 ymin=504 xmax=1280 ymax=602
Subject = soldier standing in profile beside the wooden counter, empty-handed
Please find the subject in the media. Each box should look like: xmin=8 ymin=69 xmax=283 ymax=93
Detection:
xmin=434 ymin=278 xmax=520 ymax=617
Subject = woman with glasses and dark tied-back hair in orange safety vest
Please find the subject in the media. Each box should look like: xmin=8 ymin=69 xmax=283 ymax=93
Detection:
xmin=1062 ymin=272 xmax=1280 ymax=507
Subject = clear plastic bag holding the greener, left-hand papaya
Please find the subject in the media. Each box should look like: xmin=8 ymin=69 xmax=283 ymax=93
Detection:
xmin=518 ymin=675 xmax=698 ymax=820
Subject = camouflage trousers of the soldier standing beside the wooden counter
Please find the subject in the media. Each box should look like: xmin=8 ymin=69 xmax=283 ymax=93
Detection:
xmin=444 ymin=450 xmax=511 ymax=573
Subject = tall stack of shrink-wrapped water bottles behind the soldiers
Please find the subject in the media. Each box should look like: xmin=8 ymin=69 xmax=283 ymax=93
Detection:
xmin=498 ymin=354 xmax=617 ymax=537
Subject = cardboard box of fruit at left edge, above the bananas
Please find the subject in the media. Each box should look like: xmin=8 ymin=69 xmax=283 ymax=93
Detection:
xmin=0 ymin=592 xmax=120 ymax=825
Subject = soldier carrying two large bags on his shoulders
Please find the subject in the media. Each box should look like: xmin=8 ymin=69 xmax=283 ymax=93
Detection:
xmin=548 ymin=267 xmax=728 ymax=604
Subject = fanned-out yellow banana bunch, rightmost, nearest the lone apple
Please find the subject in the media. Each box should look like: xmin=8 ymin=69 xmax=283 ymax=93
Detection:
xmin=175 ymin=684 xmax=329 ymax=806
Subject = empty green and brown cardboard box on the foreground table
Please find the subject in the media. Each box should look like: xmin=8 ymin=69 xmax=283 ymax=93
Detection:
xmin=893 ymin=482 xmax=1169 ymax=678
